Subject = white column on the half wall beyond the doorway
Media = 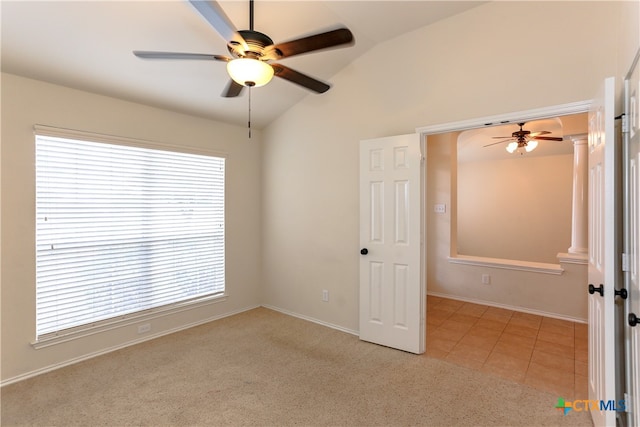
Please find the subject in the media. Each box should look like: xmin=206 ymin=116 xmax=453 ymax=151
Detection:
xmin=568 ymin=134 xmax=589 ymax=256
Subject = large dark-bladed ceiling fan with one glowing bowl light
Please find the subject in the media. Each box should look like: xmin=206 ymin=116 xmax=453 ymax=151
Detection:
xmin=133 ymin=0 xmax=353 ymax=98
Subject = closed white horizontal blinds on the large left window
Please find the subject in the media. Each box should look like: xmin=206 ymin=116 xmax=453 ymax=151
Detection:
xmin=36 ymin=135 xmax=225 ymax=338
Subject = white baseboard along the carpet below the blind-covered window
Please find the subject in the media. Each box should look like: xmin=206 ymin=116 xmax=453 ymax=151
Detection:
xmin=0 ymin=305 xmax=260 ymax=387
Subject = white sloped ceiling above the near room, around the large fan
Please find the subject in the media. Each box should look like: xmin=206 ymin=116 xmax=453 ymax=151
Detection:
xmin=0 ymin=0 xmax=482 ymax=128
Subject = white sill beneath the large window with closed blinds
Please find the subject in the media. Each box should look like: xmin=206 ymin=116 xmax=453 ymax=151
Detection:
xmin=31 ymin=293 xmax=227 ymax=350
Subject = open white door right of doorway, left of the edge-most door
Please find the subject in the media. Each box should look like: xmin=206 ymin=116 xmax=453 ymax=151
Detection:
xmin=588 ymin=78 xmax=619 ymax=427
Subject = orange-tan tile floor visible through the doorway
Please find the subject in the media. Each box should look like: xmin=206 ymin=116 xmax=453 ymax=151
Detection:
xmin=427 ymin=295 xmax=588 ymax=399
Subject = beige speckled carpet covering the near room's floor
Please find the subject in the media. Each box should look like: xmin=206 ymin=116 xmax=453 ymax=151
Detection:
xmin=1 ymin=308 xmax=591 ymax=426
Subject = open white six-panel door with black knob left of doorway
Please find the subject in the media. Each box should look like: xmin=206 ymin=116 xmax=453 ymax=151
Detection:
xmin=360 ymin=134 xmax=426 ymax=353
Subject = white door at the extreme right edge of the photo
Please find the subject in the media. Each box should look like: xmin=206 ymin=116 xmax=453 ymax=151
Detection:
xmin=623 ymin=51 xmax=640 ymax=426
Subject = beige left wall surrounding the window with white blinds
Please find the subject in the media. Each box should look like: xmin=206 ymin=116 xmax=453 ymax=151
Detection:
xmin=1 ymin=74 xmax=261 ymax=381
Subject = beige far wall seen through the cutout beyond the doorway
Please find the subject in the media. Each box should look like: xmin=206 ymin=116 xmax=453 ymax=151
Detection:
xmin=456 ymin=154 xmax=573 ymax=264
